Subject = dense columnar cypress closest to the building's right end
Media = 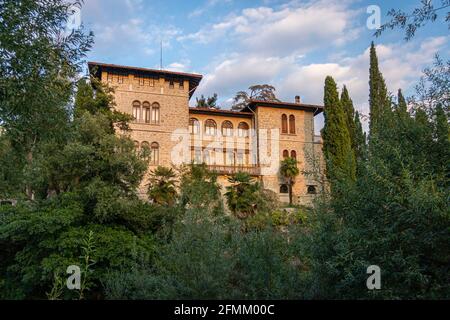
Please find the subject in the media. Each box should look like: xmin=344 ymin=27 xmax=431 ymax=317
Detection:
xmin=322 ymin=76 xmax=356 ymax=186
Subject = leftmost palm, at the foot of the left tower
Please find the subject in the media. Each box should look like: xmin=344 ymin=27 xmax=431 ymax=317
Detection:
xmin=148 ymin=166 xmax=177 ymax=206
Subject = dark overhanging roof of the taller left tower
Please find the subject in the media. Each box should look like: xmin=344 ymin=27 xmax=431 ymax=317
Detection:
xmin=88 ymin=62 xmax=203 ymax=97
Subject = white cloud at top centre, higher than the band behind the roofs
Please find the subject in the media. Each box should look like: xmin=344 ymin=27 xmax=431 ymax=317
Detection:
xmin=178 ymin=1 xmax=360 ymax=56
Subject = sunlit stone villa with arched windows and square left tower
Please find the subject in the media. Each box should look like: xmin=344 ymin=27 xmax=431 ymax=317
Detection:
xmin=89 ymin=62 xmax=323 ymax=204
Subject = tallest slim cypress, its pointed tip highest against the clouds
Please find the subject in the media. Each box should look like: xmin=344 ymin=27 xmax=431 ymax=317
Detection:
xmin=369 ymin=42 xmax=390 ymax=136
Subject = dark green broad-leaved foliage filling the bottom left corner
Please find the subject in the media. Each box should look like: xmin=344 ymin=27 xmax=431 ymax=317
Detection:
xmin=0 ymin=195 xmax=158 ymax=299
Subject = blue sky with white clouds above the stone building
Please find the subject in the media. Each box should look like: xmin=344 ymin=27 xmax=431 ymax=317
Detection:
xmin=81 ymin=0 xmax=450 ymax=131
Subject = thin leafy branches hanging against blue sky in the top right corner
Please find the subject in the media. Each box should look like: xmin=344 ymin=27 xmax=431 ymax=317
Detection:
xmin=375 ymin=0 xmax=450 ymax=41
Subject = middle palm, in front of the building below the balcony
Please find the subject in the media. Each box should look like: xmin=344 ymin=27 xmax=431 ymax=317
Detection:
xmin=225 ymin=172 xmax=259 ymax=219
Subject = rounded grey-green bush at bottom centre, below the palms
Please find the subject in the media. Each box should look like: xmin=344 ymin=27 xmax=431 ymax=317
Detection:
xmin=107 ymin=211 xmax=303 ymax=299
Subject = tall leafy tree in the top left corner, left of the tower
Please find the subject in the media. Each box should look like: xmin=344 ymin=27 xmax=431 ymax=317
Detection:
xmin=0 ymin=0 xmax=93 ymax=199
